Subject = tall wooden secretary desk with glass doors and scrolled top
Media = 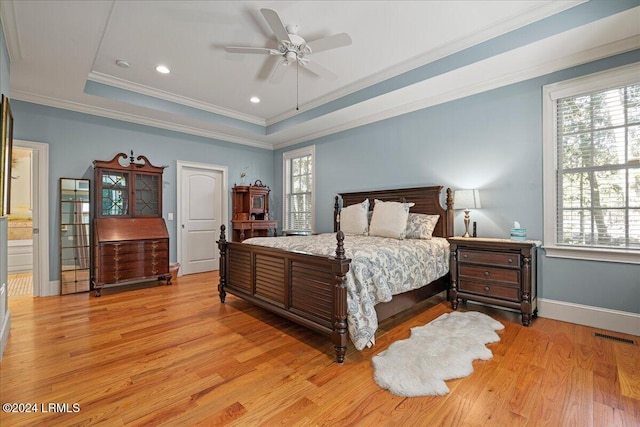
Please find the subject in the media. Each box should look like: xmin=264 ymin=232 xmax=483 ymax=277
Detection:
xmin=93 ymin=153 xmax=171 ymax=296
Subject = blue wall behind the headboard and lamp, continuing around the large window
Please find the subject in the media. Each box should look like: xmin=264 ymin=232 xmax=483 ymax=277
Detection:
xmin=273 ymin=50 xmax=640 ymax=313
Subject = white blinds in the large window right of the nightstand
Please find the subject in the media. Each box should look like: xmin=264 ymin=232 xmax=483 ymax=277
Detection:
xmin=555 ymin=81 xmax=640 ymax=252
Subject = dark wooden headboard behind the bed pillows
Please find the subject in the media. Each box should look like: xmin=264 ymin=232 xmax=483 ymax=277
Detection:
xmin=333 ymin=185 xmax=453 ymax=237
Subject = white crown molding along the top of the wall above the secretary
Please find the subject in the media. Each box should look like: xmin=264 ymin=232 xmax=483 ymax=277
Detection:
xmin=11 ymin=91 xmax=273 ymax=150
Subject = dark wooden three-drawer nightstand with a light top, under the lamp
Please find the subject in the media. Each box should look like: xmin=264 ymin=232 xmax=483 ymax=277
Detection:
xmin=449 ymin=237 xmax=540 ymax=326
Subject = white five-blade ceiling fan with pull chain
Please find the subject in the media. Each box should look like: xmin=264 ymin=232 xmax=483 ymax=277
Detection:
xmin=224 ymin=9 xmax=351 ymax=83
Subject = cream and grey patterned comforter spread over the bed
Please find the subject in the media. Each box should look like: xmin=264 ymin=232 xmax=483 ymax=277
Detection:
xmin=244 ymin=233 xmax=449 ymax=350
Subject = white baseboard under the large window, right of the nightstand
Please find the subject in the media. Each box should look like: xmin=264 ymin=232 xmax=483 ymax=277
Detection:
xmin=538 ymin=298 xmax=640 ymax=336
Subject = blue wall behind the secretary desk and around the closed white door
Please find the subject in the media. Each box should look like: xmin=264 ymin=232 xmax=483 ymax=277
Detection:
xmin=11 ymin=100 xmax=274 ymax=280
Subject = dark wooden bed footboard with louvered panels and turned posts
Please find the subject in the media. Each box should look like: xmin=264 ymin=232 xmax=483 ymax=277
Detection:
xmin=217 ymin=224 xmax=351 ymax=363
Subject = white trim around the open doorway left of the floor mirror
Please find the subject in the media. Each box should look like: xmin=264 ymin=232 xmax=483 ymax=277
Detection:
xmin=13 ymin=139 xmax=48 ymax=297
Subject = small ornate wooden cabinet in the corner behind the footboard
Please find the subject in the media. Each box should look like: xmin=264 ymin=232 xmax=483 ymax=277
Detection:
xmin=231 ymin=180 xmax=278 ymax=242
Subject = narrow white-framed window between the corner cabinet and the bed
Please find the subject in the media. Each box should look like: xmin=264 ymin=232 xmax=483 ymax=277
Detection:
xmin=282 ymin=146 xmax=315 ymax=231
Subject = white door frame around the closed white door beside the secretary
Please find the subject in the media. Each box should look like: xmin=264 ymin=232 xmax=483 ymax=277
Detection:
xmin=176 ymin=160 xmax=229 ymax=277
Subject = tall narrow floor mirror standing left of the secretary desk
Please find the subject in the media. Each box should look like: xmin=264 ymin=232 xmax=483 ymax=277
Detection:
xmin=59 ymin=178 xmax=91 ymax=295
